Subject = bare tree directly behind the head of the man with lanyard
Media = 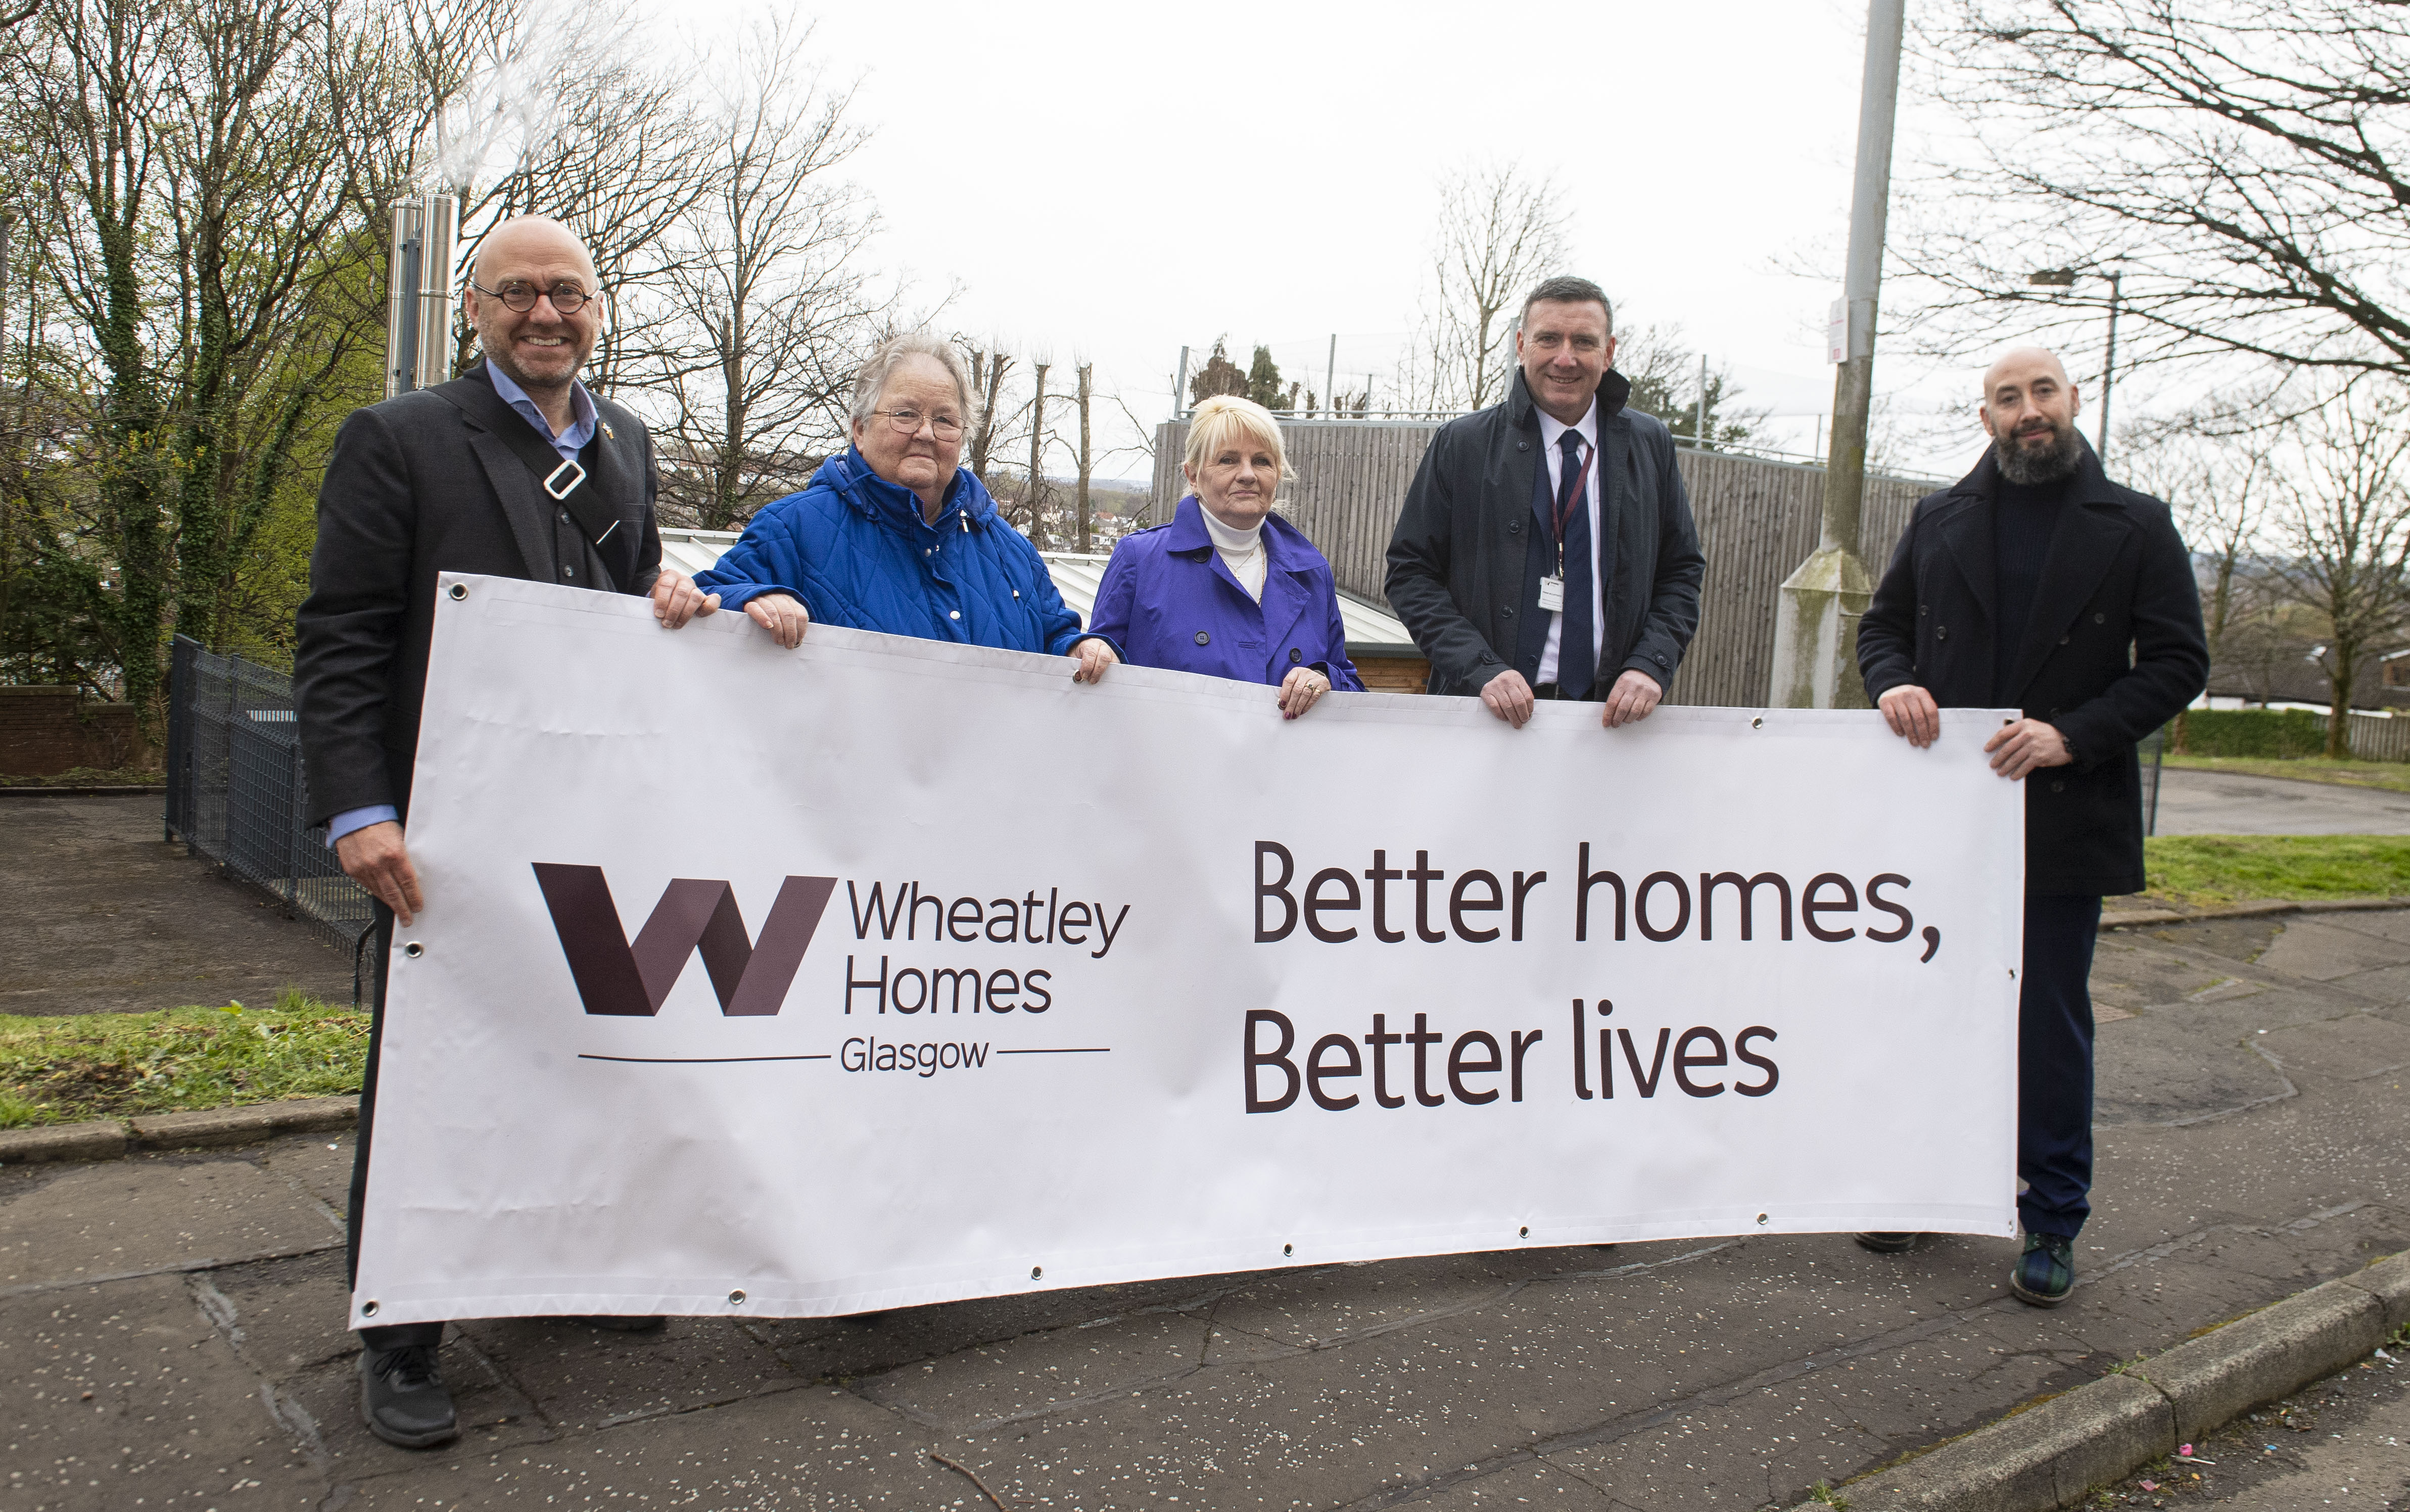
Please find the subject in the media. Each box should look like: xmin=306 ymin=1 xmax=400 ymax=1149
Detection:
xmin=1412 ymin=164 xmax=1571 ymax=410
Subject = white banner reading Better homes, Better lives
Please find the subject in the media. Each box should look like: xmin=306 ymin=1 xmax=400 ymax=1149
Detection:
xmin=352 ymin=576 xmax=2024 ymax=1324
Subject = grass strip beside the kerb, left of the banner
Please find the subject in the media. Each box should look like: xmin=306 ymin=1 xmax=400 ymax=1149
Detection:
xmin=0 ymin=991 xmax=369 ymax=1128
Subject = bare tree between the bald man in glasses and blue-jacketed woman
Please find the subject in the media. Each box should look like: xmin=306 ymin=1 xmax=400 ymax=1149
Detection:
xmin=655 ymin=22 xmax=877 ymax=531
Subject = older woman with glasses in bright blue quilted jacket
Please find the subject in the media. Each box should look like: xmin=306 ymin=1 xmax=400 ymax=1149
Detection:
xmin=694 ymin=335 xmax=1118 ymax=682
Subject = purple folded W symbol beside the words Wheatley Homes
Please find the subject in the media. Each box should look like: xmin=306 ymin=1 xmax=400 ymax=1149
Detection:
xmin=535 ymin=861 xmax=836 ymax=1018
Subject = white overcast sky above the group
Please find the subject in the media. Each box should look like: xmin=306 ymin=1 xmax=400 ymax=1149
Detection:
xmin=675 ymin=0 xmax=1978 ymax=475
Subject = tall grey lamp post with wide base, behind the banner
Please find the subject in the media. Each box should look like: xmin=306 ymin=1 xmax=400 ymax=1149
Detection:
xmin=1767 ymin=0 xmax=1906 ymax=709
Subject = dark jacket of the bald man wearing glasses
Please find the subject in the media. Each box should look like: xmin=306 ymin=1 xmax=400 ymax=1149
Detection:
xmin=294 ymin=364 xmax=660 ymax=825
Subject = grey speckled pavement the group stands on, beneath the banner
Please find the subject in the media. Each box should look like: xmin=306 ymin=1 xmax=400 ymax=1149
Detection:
xmin=0 ymin=912 xmax=2410 ymax=1512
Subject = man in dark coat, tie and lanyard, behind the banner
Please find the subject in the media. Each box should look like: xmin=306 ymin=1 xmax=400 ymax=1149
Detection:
xmin=1386 ymin=277 xmax=1706 ymax=728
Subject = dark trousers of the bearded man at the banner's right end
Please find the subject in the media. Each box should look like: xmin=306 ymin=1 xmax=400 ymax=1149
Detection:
xmin=2017 ymin=894 xmax=2102 ymax=1240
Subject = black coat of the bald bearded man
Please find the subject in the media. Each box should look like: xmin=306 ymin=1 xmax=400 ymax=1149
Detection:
xmin=1858 ymin=446 xmax=2210 ymax=894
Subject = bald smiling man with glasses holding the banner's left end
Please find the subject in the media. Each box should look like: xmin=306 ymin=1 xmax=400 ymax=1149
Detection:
xmin=294 ymin=217 xmax=718 ymax=1449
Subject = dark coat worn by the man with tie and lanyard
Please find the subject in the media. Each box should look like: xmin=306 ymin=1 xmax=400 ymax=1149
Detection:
xmin=1386 ymin=369 xmax=1706 ymax=699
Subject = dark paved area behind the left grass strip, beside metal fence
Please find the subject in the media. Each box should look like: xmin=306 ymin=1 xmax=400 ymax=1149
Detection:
xmin=0 ymin=796 xmax=352 ymax=1013
